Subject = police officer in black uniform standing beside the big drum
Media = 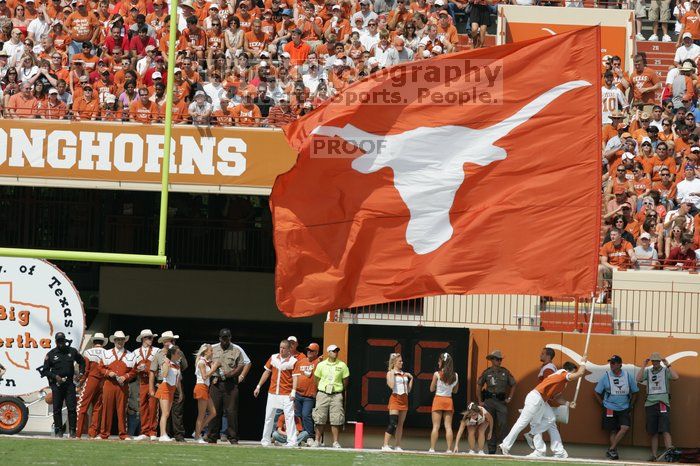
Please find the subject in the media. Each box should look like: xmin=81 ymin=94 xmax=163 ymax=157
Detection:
xmin=42 ymin=332 xmax=85 ymax=438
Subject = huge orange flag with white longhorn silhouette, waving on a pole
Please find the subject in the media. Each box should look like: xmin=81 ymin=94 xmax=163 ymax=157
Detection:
xmin=270 ymin=27 xmax=601 ymax=317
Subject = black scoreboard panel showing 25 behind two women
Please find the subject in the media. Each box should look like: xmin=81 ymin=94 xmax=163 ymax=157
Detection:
xmin=346 ymin=325 xmax=469 ymax=427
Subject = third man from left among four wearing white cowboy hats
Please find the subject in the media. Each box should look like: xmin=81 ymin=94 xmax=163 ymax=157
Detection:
xmin=134 ymin=329 xmax=158 ymax=440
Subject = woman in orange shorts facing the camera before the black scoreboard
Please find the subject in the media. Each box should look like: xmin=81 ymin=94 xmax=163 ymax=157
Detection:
xmin=382 ymin=353 xmax=413 ymax=451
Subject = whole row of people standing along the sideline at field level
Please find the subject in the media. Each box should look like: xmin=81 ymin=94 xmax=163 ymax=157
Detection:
xmin=37 ymin=328 xmax=679 ymax=459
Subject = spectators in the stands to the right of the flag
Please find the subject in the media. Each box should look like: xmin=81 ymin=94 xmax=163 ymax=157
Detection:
xmin=599 ymin=42 xmax=700 ymax=301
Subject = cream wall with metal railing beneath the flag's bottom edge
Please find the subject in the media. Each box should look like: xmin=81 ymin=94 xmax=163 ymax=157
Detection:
xmin=330 ymin=283 xmax=700 ymax=338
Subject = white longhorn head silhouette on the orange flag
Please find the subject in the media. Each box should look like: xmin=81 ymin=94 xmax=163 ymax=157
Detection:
xmin=311 ymin=81 xmax=591 ymax=254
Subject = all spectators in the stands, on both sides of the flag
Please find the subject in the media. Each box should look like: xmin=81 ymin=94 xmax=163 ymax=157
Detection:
xmin=0 ymin=0 xmax=700 ymax=274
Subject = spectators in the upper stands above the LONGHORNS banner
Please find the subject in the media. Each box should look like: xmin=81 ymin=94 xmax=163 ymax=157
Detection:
xmin=0 ymin=0 xmax=484 ymax=126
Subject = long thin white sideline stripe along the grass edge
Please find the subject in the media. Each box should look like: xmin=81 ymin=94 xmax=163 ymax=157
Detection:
xmin=0 ymin=434 xmax=651 ymax=466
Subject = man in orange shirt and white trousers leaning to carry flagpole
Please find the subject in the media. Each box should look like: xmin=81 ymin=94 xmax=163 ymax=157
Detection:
xmin=499 ymin=356 xmax=586 ymax=458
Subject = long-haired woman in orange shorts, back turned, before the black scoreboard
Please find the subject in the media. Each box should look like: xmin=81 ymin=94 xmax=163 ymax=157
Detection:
xmin=428 ymin=353 xmax=459 ymax=453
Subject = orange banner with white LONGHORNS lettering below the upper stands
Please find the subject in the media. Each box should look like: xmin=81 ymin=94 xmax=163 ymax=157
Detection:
xmin=0 ymin=120 xmax=295 ymax=192
